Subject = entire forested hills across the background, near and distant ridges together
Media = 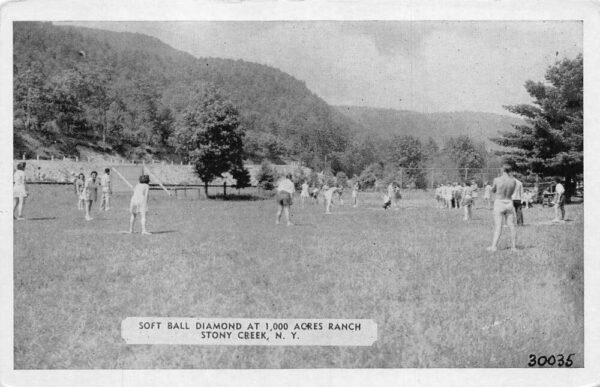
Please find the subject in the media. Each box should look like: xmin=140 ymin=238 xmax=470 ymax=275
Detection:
xmin=13 ymin=22 xmax=508 ymax=185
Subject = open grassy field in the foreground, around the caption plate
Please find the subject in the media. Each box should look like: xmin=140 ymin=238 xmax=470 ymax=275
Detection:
xmin=14 ymin=186 xmax=583 ymax=369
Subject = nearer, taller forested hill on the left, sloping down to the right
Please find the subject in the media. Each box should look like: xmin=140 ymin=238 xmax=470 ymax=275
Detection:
xmin=14 ymin=22 xmax=353 ymax=166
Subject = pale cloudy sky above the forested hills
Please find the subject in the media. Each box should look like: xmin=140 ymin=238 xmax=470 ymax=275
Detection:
xmin=62 ymin=21 xmax=583 ymax=114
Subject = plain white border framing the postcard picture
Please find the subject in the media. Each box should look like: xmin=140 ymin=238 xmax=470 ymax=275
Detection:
xmin=0 ymin=0 xmax=600 ymax=387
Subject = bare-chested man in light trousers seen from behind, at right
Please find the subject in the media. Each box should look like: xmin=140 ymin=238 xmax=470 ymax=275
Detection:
xmin=487 ymin=165 xmax=517 ymax=251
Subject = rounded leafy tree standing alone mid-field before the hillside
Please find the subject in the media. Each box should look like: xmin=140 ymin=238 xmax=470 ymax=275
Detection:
xmin=171 ymin=87 xmax=244 ymax=196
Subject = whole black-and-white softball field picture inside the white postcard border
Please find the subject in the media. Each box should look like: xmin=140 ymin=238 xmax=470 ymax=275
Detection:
xmin=2 ymin=2 xmax=598 ymax=385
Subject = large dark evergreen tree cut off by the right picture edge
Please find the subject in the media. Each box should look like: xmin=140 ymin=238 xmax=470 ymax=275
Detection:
xmin=492 ymin=54 xmax=583 ymax=197
